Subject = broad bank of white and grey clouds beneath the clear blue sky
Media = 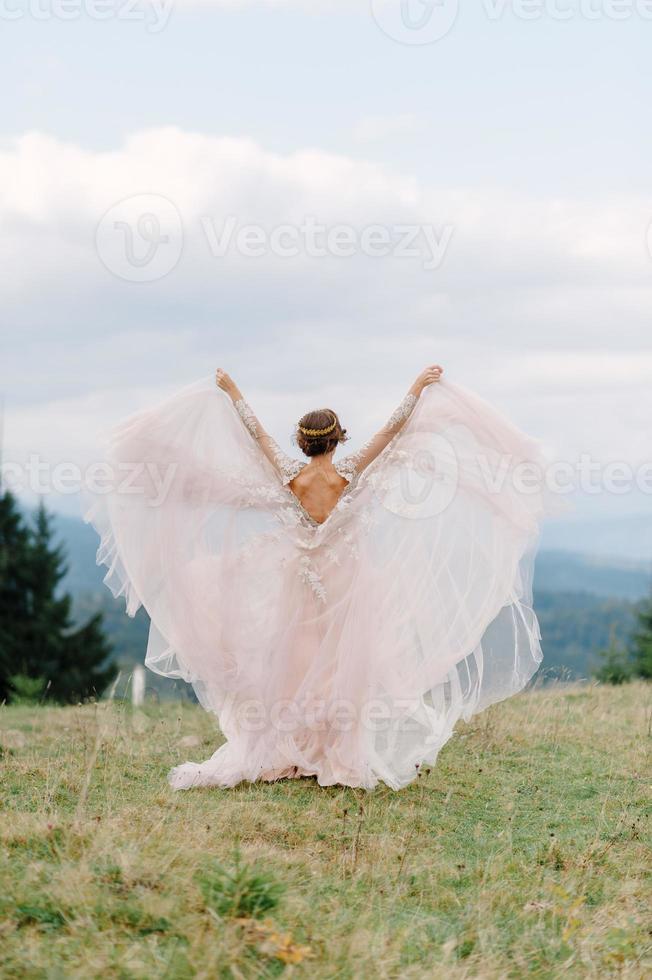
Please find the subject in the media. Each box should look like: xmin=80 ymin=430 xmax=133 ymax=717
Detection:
xmin=0 ymin=123 xmax=652 ymax=516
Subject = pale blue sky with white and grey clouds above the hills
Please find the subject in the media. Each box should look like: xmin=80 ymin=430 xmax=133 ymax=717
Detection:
xmin=0 ymin=0 xmax=652 ymax=518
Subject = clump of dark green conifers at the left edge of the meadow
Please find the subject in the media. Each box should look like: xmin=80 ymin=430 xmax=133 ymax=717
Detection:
xmin=0 ymin=494 xmax=117 ymax=701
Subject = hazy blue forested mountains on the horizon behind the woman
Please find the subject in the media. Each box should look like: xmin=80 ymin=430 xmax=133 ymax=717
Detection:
xmin=47 ymin=515 xmax=651 ymax=691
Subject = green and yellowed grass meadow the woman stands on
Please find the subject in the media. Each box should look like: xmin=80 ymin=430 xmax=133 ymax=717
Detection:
xmin=0 ymin=682 xmax=652 ymax=980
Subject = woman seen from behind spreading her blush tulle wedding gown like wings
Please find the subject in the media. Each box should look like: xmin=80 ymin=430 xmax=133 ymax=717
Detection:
xmin=86 ymin=365 xmax=545 ymax=789
